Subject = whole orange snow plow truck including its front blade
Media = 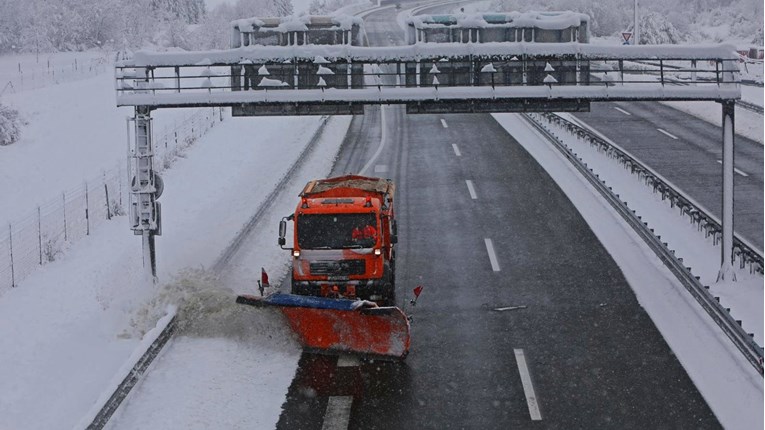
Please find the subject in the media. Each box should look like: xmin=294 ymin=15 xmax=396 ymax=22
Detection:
xmin=237 ymin=175 xmax=409 ymax=359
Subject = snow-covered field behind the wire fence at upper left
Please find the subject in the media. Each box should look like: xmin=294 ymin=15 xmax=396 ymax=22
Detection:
xmin=0 ymin=67 xmax=206 ymax=226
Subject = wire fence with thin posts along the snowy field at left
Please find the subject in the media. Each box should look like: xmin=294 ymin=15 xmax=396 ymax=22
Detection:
xmin=0 ymin=108 xmax=223 ymax=294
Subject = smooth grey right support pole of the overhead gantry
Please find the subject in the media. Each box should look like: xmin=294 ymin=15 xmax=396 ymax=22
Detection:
xmin=717 ymin=100 xmax=736 ymax=282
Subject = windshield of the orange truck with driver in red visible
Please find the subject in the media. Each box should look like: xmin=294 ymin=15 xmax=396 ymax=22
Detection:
xmin=297 ymin=213 xmax=378 ymax=249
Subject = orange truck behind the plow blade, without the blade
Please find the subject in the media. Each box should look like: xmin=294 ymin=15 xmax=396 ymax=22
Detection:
xmin=279 ymin=175 xmax=397 ymax=305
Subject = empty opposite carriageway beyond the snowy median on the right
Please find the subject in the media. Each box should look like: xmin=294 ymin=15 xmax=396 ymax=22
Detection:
xmin=576 ymin=102 xmax=764 ymax=250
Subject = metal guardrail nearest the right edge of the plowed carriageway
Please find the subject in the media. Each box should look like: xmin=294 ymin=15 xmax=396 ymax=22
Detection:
xmin=525 ymin=115 xmax=763 ymax=375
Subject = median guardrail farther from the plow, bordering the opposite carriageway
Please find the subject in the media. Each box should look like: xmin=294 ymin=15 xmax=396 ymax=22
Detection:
xmin=544 ymin=114 xmax=765 ymax=274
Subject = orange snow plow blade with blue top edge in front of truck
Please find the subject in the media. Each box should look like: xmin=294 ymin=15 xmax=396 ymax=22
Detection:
xmin=236 ymin=294 xmax=409 ymax=359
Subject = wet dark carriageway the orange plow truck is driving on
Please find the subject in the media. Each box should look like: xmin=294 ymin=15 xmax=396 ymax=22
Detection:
xmin=278 ymin=4 xmax=720 ymax=430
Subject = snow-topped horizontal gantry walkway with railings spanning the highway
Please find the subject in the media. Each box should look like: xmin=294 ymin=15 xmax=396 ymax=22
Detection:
xmin=115 ymin=43 xmax=741 ymax=113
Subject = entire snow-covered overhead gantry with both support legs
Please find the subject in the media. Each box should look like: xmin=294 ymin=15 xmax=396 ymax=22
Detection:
xmin=115 ymin=20 xmax=741 ymax=279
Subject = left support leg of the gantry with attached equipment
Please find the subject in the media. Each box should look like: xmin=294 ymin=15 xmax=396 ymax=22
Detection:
xmin=130 ymin=106 xmax=161 ymax=282
